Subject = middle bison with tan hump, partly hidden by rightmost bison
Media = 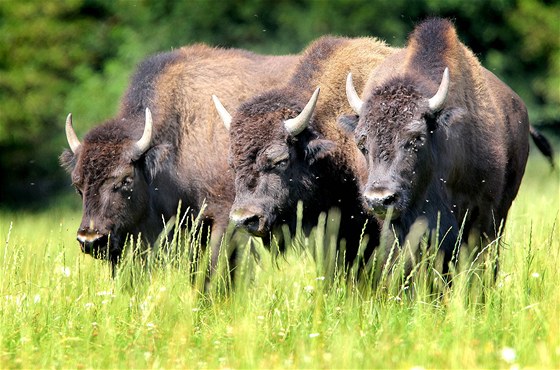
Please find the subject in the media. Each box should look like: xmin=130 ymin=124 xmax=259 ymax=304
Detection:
xmin=211 ymin=37 xmax=395 ymax=261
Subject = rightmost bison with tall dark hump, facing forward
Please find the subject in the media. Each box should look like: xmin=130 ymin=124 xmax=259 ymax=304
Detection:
xmin=345 ymin=19 xmax=552 ymax=267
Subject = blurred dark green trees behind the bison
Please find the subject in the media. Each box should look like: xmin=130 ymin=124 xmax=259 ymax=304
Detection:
xmin=0 ymin=0 xmax=560 ymax=209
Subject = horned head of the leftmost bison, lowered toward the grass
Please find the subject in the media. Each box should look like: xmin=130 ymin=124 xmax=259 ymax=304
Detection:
xmin=61 ymin=109 xmax=164 ymax=262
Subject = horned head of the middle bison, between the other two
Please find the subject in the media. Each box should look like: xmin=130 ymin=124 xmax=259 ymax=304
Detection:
xmin=214 ymin=89 xmax=335 ymax=236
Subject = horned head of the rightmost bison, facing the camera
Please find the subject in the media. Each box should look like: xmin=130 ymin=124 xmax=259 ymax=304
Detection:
xmin=344 ymin=68 xmax=460 ymax=219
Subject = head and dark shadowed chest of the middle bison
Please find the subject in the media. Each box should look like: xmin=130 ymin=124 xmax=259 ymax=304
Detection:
xmin=214 ymin=85 xmax=378 ymax=264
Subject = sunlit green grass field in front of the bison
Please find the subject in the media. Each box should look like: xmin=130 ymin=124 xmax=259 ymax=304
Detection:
xmin=0 ymin=153 xmax=560 ymax=369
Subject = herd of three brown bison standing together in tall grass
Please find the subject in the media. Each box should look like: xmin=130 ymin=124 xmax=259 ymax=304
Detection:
xmin=60 ymin=18 xmax=552 ymax=280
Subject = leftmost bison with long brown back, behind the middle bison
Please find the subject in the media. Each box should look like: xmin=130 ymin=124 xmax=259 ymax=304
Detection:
xmin=61 ymin=44 xmax=297 ymax=264
